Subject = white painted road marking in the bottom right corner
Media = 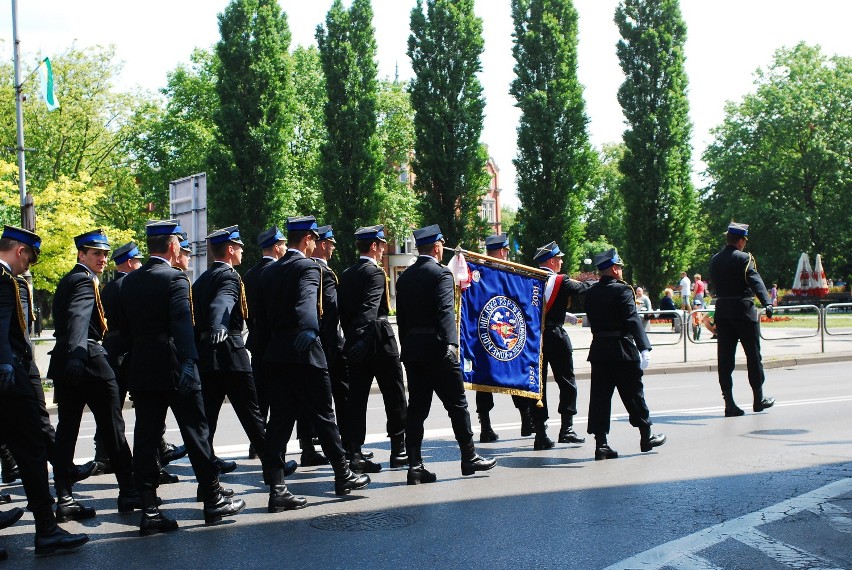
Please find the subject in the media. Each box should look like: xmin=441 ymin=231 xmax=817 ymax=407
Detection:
xmin=605 ymin=478 xmax=852 ymax=570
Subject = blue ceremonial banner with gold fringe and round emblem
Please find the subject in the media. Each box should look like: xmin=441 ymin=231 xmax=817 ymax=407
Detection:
xmin=459 ymin=256 xmax=544 ymax=400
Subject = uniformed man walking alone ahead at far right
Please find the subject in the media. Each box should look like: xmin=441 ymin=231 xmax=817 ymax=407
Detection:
xmin=710 ymin=222 xmax=775 ymax=417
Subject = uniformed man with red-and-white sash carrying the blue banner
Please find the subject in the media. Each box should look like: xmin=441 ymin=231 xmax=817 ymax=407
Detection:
xmin=531 ymin=241 xmax=589 ymax=450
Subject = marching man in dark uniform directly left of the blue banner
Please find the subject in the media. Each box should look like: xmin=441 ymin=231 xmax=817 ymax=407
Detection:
xmin=396 ymin=225 xmax=497 ymax=485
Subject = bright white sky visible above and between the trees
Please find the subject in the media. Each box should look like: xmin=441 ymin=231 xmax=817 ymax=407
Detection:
xmin=5 ymin=0 xmax=852 ymax=207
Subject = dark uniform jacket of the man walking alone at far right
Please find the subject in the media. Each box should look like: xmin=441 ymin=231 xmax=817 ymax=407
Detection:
xmin=710 ymin=245 xmax=772 ymax=322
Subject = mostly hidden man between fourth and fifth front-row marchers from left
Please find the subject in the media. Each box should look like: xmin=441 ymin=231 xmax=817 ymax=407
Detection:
xmin=243 ymin=226 xmax=287 ymax=432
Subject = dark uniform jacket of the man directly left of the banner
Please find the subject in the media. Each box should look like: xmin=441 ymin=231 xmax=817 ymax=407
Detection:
xmin=396 ymin=256 xmax=459 ymax=362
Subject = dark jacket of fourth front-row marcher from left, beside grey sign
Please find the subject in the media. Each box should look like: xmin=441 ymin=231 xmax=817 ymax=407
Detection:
xmin=192 ymin=261 xmax=251 ymax=372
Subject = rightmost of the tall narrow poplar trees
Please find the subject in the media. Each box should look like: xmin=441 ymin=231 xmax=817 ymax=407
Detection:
xmin=615 ymin=0 xmax=698 ymax=293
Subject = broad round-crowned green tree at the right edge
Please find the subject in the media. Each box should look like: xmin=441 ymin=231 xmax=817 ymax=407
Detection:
xmin=703 ymin=43 xmax=852 ymax=285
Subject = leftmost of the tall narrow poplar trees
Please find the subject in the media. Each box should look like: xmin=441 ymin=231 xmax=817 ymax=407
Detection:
xmin=208 ymin=0 xmax=294 ymax=267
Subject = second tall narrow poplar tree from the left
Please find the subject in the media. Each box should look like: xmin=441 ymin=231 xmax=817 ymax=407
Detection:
xmin=316 ymin=0 xmax=382 ymax=267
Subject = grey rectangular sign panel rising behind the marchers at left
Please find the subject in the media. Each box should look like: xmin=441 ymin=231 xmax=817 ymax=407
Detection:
xmin=169 ymin=172 xmax=207 ymax=282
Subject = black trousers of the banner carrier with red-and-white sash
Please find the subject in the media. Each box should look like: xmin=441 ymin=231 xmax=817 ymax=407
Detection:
xmin=530 ymin=325 xmax=577 ymax=423
